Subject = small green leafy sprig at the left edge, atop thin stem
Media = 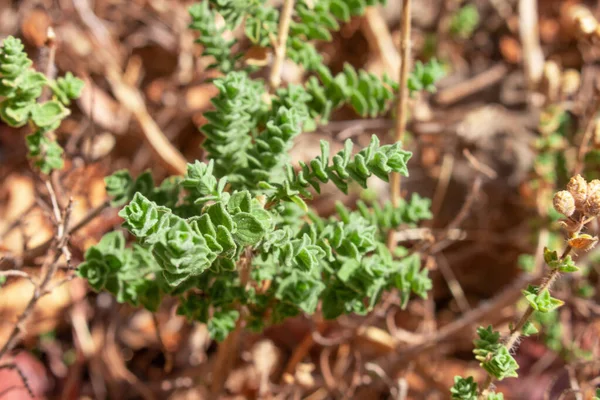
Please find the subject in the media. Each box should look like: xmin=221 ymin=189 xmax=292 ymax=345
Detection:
xmin=0 ymin=36 xmax=83 ymax=174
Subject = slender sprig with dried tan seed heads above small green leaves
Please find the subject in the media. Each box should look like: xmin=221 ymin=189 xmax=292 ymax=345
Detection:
xmin=451 ymin=175 xmax=600 ymax=399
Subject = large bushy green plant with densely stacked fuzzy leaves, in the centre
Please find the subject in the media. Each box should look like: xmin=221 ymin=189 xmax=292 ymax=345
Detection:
xmin=78 ymin=0 xmax=443 ymax=340
